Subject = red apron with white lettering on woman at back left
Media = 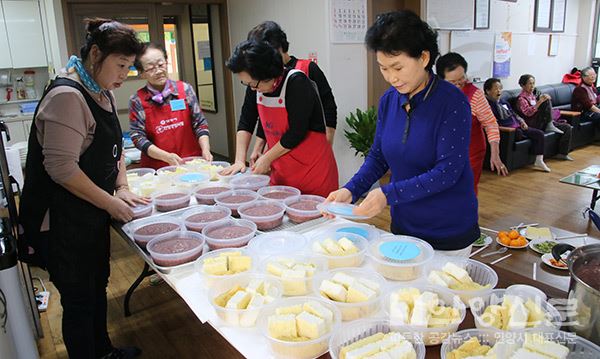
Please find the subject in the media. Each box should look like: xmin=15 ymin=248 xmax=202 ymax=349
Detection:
xmin=137 ymin=81 xmax=202 ymax=169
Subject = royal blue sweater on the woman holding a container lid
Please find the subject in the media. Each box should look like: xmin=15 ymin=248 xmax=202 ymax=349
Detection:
xmin=344 ymin=74 xmax=480 ymax=250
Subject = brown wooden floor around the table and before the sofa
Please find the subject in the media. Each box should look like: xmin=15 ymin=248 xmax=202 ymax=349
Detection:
xmin=35 ymin=145 xmax=600 ymax=358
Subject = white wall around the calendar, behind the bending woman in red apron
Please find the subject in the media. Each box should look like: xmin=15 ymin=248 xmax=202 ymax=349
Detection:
xmin=228 ymin=0 xmax=367 ymax=185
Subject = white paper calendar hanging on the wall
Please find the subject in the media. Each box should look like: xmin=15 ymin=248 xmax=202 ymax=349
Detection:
xmin=330 ymin=0 xmax=367 ymax=43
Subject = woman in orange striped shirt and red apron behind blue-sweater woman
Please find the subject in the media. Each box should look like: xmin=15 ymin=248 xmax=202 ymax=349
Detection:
xmin=435 ymin=52 xmax=508 ymax=193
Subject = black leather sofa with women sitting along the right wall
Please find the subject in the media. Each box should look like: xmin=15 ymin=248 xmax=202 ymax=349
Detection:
xmin=484 ymin=83 xmax=600 ymax=171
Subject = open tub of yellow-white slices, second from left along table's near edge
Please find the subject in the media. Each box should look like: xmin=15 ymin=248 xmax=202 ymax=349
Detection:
xmin=208 ymin=273 xmax=283 ymax=327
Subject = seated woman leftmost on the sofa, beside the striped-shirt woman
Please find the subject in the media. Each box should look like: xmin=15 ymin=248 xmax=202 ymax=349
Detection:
xmin=483 ymin=78 xmax=550 ymax=172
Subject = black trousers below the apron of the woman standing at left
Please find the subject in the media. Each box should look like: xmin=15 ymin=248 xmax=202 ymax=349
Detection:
xmin=54 ymin=276 xmax=113 ymax=359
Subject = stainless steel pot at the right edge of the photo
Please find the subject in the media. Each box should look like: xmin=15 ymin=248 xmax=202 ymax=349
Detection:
xmin=552 ymin=244 xmax=600 ymax=345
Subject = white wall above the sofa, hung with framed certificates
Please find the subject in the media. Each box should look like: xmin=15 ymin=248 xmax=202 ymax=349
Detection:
xmin=439 ymin=0 xmax=595 ymax=89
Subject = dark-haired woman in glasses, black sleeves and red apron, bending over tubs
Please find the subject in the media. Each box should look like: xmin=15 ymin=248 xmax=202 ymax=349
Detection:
xmin=225 ymin=41 xmax=338 ymax=196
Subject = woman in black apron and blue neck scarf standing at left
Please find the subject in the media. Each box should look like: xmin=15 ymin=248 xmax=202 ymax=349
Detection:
xmin=20 ymin=19 xmax=145 ymax=358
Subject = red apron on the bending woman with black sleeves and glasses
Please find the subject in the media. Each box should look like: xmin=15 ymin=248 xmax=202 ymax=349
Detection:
xmin=256 ymin=70 xmax=338 ymax=197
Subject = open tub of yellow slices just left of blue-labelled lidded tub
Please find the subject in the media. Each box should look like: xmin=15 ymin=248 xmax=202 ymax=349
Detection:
xmin=310 ymin=231 xmax=369 ymax=269
